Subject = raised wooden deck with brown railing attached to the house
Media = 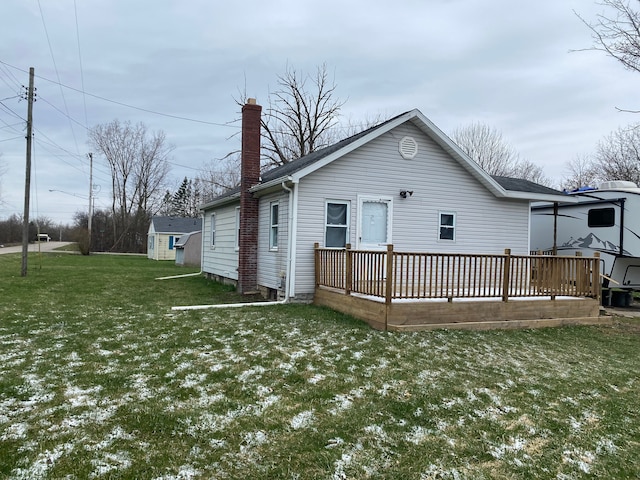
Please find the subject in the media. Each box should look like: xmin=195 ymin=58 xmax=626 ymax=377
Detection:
xmin=314 ymin=246 xmax=610 ymax=331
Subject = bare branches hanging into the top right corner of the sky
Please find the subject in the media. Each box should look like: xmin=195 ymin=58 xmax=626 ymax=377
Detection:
xmin=576 ymin=0 xmax=640 ymax=109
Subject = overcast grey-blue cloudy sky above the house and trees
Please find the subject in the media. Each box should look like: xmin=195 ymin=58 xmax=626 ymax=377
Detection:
xmin=0 ymin=0 xmax=640 ymax=223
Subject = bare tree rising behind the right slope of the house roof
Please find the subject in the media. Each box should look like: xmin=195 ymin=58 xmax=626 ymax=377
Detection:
xmin=452 ymin=122 xmax=551 ymax=185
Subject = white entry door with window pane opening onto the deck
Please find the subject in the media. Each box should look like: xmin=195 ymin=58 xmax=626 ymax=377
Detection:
xmin=358 ymin=197 xmax=392 ymax=250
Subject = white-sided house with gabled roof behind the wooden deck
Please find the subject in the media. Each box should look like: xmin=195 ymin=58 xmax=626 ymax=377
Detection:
xmin=202 ymin=106 xmax=564 ymax=300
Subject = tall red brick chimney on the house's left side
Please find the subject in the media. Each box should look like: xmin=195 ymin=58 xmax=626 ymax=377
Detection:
xmin=238 ymin=98 xmax=262 ymax=294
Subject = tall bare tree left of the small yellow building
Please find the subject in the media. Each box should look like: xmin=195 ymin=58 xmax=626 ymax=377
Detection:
xmin=89 ymin=120 xmax=172 ymax=251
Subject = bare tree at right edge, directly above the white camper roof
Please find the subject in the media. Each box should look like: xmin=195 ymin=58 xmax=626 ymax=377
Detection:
xmin=594 ymin=124 xmax=640 ymax=185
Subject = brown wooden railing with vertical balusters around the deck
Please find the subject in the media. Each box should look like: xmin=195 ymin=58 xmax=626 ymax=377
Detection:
xmin=315 ymin=244 xmax=600 ymax=303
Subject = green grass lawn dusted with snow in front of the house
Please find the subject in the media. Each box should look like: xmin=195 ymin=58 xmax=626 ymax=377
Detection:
xmin=0 ymin=253 xmax=640 ymax=480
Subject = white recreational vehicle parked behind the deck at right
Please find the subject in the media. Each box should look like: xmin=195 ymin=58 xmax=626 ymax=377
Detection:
xmin=531 ymin=181 xmax=640 ymax=290
